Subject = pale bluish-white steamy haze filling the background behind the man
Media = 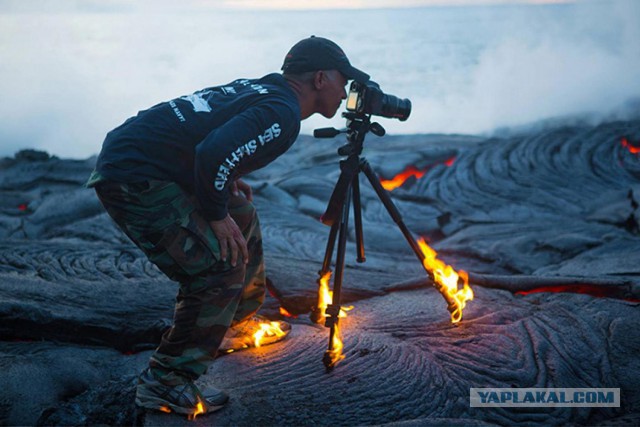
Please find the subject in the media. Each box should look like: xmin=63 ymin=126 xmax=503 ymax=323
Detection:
xmin=0 ymin=0 xmax=640 ymax=158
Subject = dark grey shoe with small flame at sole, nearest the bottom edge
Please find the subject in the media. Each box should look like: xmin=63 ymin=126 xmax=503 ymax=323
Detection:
xmin=136 ymin=368 xmax=229 ymax=416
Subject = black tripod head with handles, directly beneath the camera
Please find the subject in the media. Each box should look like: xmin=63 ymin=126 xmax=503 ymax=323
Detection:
xmin=313 ymin=111 xmax=386 ymax=156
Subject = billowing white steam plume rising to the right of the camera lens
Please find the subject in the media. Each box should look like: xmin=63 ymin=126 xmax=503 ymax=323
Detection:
xmin=416 ymin=1 xmax=640 ymax=133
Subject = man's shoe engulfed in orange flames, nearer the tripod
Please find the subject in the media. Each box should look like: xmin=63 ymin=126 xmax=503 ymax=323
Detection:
xmin=218 ymin=314 xmax=291 ymax=353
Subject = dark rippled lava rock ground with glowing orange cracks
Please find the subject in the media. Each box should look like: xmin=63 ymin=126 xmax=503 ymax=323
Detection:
xmin=0 ymin=121 xmax=640 ymax=426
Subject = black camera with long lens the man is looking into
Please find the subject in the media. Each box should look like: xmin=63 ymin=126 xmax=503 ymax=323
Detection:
xmin=347 ymin=80 xmax=411 ymax=122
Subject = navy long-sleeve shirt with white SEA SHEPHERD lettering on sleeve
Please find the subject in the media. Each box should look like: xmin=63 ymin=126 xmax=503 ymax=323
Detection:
xmin=96 ymin=73 xmax=300 ymax=220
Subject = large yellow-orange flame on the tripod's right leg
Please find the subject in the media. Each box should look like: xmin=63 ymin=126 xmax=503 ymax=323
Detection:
xmin=418 ymin=238 xmax=473 ymax=323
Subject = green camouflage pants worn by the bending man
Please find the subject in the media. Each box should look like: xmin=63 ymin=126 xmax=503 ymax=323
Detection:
xmin=96 ymin=181 xmax=265 ymax=385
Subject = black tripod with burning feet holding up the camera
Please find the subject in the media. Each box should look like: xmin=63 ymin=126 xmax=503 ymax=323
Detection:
xmin=312 ymin=112 xmax=455 ymax=370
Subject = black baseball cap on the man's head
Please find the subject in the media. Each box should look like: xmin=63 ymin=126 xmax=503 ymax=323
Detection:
xmin=282 ymin=36 xmax=369 ymax=83
